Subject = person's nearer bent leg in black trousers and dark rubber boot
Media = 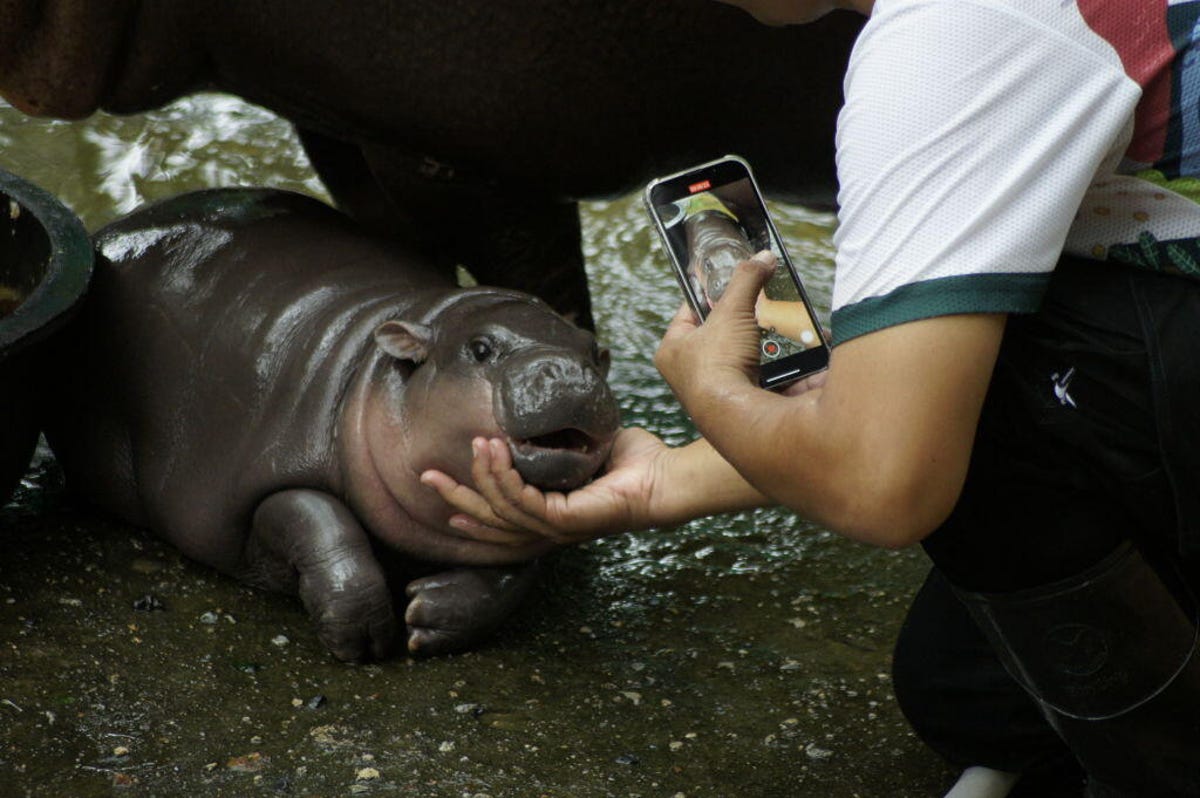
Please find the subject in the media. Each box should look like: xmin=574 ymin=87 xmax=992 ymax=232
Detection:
xmin=925 ymin=258 xmax=1200 ymax=796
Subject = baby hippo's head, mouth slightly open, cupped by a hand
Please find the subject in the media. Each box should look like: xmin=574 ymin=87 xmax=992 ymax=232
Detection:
xmin=374 ymin=289 xmax=620 ymax=491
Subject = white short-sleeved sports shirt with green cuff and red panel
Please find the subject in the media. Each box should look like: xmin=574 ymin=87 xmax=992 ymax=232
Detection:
xmin=833 ymin=0 xmax=1200 ymax=343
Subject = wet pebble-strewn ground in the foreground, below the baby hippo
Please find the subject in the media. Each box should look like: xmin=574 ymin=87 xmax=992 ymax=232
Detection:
xmin=0 ymin=441 xmax=950 ymax=798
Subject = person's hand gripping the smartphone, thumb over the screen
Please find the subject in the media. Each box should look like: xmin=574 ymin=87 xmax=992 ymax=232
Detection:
xmin=654 ymin=251 xmax=775 ymax=412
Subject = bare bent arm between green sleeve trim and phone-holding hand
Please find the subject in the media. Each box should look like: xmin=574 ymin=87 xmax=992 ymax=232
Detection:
xmin=683 ymin=316 xmax=1003 ymax=547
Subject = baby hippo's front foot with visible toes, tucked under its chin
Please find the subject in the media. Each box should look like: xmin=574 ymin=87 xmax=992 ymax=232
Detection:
xmin=404 ymin=564 xmax=536 ymax=656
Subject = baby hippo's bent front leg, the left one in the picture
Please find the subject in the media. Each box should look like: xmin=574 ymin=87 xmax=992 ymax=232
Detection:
xmin=242 ymin=490 xmax=397 ymax=660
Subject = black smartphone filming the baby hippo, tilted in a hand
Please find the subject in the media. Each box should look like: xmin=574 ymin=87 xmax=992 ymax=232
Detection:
xmin=644 ymin=155 xmax=829 ymax=389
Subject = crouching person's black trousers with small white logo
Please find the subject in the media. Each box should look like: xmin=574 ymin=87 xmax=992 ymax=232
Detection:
xmin=894 ymin=259 xmax=1200 ymax=770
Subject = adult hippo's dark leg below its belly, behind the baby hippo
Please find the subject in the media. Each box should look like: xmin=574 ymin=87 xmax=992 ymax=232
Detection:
xmin=299 ymin=130 xmax=595 ymax=330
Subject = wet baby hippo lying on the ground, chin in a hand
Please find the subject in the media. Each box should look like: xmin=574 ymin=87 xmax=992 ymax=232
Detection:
xmin=39 ymin=190 xmax=619 ymax=660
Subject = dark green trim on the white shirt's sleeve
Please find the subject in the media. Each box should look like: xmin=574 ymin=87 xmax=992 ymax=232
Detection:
xmin=830 ymin=272 xmax=1050 ymax=346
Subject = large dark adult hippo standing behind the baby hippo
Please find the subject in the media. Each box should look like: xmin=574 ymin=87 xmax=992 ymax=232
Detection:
xmin=0 ymin=0 xmax=863 ymax=325
